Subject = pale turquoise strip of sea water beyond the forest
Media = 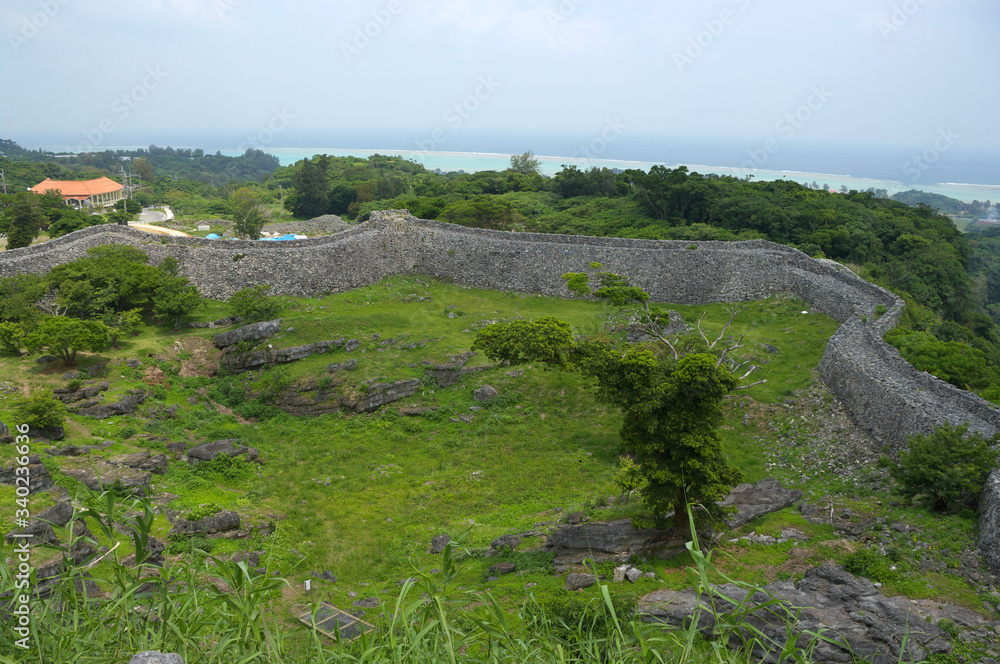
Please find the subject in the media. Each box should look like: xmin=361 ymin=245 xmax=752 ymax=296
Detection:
xmin=222 ymin=148 xmax=1000 ymax=202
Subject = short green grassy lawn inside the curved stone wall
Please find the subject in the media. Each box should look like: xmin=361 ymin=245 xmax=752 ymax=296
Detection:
xmin=0 ymin=277 xmax=988 ymax=644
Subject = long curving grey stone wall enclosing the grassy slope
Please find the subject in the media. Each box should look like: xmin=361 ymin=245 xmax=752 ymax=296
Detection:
xmin=0 ymin=211 xmax=1000 ymax=560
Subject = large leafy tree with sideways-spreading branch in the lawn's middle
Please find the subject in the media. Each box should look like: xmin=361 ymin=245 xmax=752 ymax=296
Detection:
xmin=472 ymin=318 xmax=741 ymax=533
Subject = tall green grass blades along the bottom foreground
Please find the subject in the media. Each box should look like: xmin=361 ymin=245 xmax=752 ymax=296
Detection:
xmin=0 ymin=495 xmax=852 ymax=664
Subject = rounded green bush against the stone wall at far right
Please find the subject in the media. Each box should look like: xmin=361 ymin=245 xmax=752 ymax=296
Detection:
xmin=890 ymin=423 xmax=1000 ymax=512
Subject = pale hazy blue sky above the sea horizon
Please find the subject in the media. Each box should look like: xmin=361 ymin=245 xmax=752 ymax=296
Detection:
xmin=0 ymin=0 xmax=1000 ymax=178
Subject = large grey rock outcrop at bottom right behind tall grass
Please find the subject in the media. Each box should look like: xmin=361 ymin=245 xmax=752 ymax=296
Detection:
xmin=639 ymin=565 xmax=956 ymax=664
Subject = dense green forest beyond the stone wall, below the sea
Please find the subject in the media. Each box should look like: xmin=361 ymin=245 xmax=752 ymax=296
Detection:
xmin=0 ymin=137 xmax=1000 ymax=401
